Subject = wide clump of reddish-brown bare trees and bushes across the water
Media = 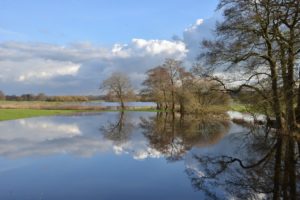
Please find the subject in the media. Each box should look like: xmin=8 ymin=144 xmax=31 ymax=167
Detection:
xmin=142 ymin=59 xmax=228 ymax=113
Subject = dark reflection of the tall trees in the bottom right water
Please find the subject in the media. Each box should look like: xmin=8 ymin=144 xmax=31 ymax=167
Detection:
xmin=187 ymin=127 xmax=300 ymax=199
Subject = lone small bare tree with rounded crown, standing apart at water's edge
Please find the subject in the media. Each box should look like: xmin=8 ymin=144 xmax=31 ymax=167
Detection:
xmin=100 ymin=72 xmax=133 ymax=109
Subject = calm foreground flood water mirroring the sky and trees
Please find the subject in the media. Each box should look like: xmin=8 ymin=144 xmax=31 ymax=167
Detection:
xmin=0 ymin=112 xmax=300 ymax=200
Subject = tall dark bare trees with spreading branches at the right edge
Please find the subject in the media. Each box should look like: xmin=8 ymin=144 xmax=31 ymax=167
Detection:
xmin=198 ymin=0 xmax=300 ymax=133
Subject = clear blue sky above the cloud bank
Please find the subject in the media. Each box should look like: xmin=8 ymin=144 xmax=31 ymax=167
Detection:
xmin=0 ymin=0 xmax=217 ymax=45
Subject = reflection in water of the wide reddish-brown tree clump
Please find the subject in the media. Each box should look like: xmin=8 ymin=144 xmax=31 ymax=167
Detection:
xmin=140 ymin=113 xmax=229 ymax=160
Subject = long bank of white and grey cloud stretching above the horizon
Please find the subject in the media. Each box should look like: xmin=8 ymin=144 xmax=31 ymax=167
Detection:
xmin=0 ymin=39 xmax=187 ymax=94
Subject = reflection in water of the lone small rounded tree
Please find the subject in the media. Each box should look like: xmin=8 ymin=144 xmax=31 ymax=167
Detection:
xmin=100 ymin=112 xmax=133 ymax=144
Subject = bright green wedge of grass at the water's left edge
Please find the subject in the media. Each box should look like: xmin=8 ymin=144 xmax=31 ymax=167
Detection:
xmin=0 ymin=109 xmax=79 ymax=121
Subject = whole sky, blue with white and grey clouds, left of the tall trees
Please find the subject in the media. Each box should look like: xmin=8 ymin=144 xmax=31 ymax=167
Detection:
xmin=0 ymin=0 xmax=220 ymax=95
